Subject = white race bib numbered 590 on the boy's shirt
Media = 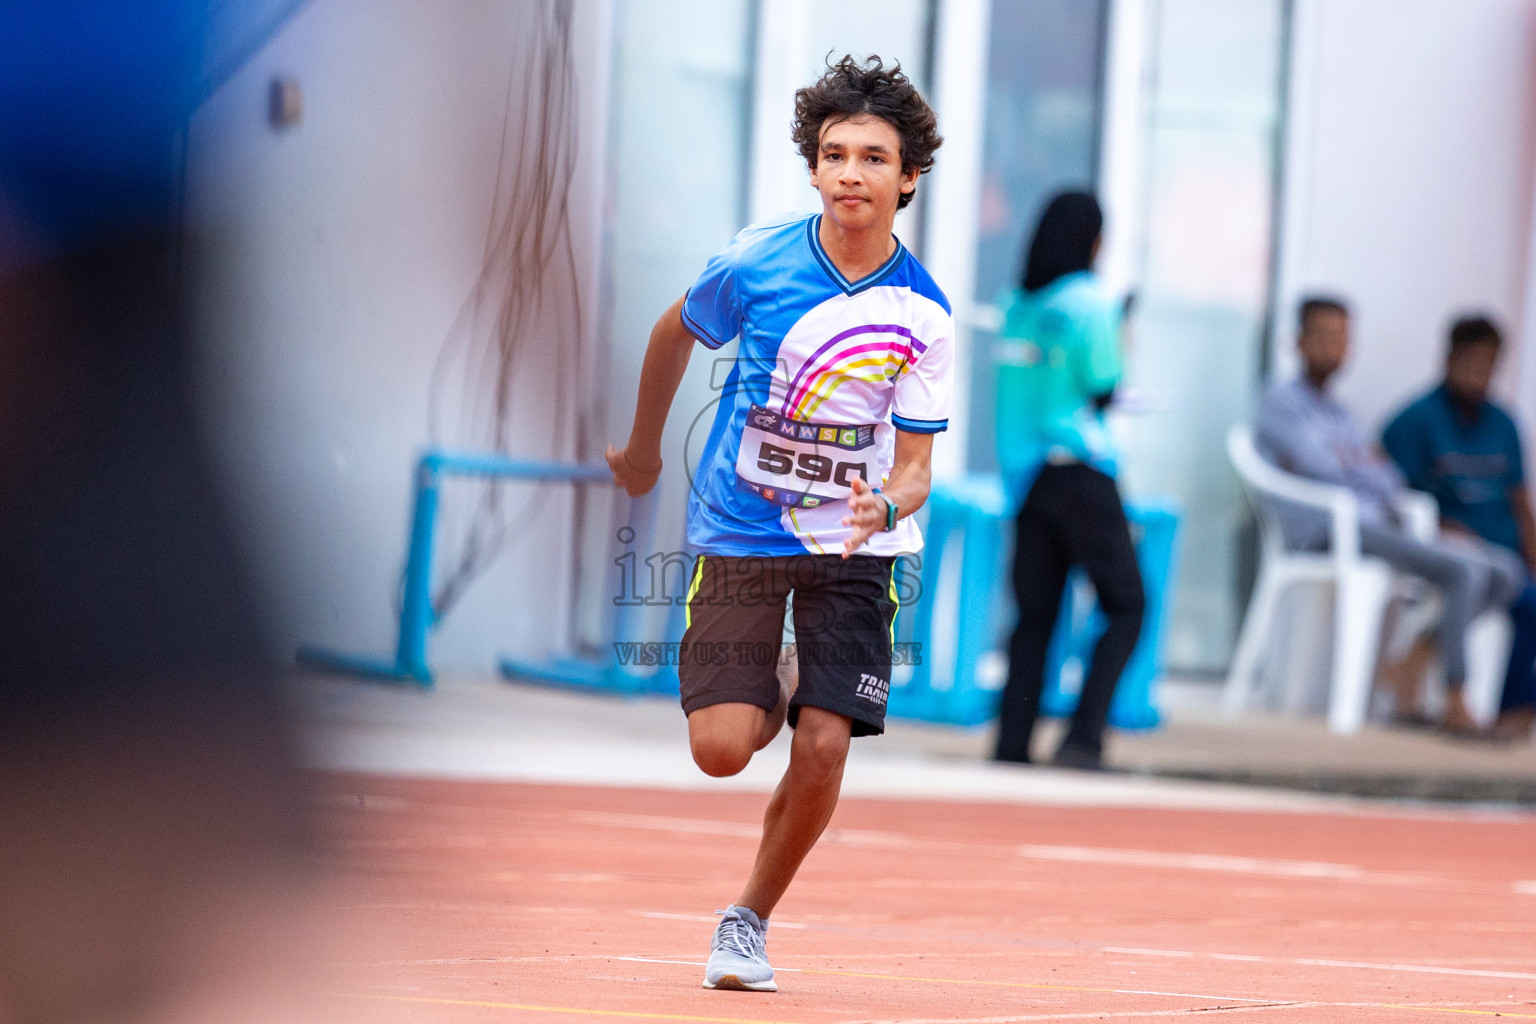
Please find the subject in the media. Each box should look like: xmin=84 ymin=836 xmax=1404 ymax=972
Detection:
xmin=736 ymin=405 xmax=879 ymax=508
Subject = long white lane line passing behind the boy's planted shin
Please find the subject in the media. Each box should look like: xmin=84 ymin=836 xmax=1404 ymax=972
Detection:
xmin=571 ymin=812 xmax=1499 ymax=894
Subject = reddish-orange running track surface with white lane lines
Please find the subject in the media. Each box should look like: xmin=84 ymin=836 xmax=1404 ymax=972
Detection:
xmin=316 ymin=775 xmax=1536 ymax=1024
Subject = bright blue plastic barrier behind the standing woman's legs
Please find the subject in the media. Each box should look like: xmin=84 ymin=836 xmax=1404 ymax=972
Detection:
xmin=889 ymin=474 xmax=1178 ymax=729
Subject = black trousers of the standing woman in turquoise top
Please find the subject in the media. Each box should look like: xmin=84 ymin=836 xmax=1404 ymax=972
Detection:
xmin=997 ymin=464 xmax=1146 ymax=761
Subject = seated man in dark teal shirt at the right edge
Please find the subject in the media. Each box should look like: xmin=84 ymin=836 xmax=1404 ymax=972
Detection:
xmin=1381 ymin=316 xmax=1536 ymax=738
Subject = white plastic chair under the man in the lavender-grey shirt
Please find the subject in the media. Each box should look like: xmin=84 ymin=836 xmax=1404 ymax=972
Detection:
xmin=1221 ymin=424 xmax=1400 ymax=734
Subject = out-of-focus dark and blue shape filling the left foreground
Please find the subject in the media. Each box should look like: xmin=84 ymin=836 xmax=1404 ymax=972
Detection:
xmin=0 ymin=0 xmax=314 ymax=1022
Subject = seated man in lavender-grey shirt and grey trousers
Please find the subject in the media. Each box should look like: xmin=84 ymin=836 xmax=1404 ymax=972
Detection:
xmin=1255 ymin=298 xmax=1522 ymax=735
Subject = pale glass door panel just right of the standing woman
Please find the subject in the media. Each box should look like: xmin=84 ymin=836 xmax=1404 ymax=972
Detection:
xmin=1114 ymin=0 xmax=1287 ymax=672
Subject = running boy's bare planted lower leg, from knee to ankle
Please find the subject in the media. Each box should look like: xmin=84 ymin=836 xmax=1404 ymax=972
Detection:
xmin=736 ymin=708 xmax=852 ymax=920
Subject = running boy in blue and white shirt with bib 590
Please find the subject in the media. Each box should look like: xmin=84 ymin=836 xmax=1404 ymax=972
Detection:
xmin=608 ymin=57 xmax=954 ymax=992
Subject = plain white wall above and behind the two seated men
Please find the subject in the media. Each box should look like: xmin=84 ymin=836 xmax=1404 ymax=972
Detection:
xmin=1272 ymin=0 xmax=1536 ymax=436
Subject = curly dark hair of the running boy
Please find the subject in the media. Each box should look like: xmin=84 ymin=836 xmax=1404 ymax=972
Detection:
xmin=791 ymin=54 xmax=945 ymax=209
